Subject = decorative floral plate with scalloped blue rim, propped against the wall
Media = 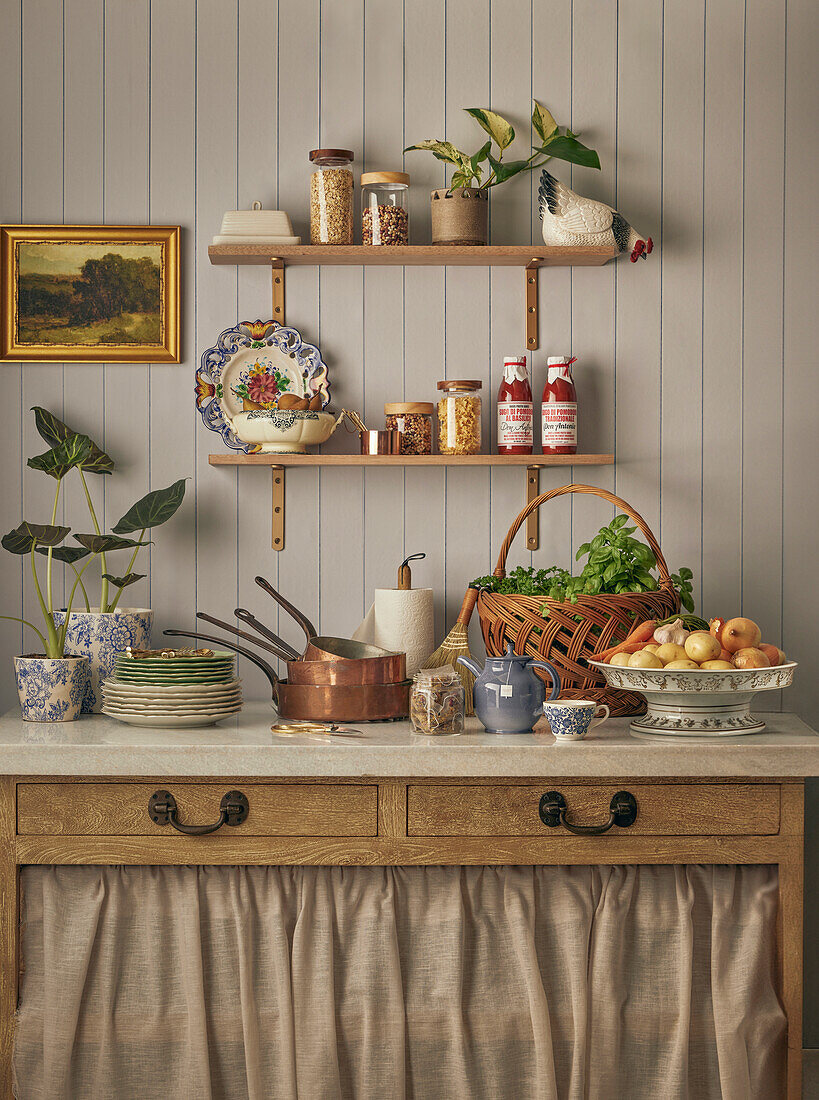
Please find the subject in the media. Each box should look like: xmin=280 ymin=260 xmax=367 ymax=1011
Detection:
xmin=196 ymin=321 xmax=330 ymax=454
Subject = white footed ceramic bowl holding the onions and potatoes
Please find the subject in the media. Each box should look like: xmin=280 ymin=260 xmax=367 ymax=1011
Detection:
xmin=588 ymin=661 xmax=796 ymax=737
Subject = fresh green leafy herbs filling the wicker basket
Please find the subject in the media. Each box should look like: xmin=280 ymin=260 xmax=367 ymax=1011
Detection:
xmin=472 ymin=515 xmax=694 ymax=615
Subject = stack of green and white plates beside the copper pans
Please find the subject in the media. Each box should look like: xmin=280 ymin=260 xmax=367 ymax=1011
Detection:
xmin=102 ymin=653 xmax=242 ymax=728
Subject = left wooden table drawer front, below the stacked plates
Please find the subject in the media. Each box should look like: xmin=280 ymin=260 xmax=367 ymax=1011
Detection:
xmin=18 ymin=780 xmax=378 ymax=837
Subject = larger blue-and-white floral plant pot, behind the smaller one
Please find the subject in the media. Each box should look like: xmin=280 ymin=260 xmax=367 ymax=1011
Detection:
xmin=54 ymin=607 xmax=154 ymax=714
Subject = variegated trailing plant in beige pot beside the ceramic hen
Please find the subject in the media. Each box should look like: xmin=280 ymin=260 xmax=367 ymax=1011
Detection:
xmin=405 ymin=99 xmax=600 ymax=244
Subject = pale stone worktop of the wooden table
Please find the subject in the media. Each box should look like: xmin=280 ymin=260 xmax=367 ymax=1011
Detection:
xmin=0 ymin=703 xmax=819 ymax=779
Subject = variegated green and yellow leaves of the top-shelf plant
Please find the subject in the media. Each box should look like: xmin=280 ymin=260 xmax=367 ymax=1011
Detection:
xmin=403 ymin=99 xmax=600 ymax=190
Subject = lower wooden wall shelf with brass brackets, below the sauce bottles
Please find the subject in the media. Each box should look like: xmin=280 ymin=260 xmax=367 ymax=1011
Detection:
xmin=208 ymin=451 xmax=615 ymax=550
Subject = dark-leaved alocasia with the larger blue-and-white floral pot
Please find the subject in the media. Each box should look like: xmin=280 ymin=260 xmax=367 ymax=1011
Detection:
xmin=10 ymin=406 xmax=185 ymax=713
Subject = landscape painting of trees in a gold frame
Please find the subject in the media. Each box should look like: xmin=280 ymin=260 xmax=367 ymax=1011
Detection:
xmin=0 ymin=226 xmax=179 ymax=363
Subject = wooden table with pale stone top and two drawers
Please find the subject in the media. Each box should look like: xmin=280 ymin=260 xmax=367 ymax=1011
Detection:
xmin=0 ymin=704 xmax=819 ymax=1100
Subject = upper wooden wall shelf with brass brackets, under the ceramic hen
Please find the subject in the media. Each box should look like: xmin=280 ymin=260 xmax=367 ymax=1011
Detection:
xmin=208 ymin=244 xmax=618 ymax=351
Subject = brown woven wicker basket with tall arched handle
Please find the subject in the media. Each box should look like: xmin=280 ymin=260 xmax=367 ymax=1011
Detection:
xmin=478 ymin=485 xmax=679 ymax=716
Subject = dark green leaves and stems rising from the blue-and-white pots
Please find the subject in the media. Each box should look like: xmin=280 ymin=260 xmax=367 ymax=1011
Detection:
xmin=0 ymin=406 xmax=185 ymax=658
